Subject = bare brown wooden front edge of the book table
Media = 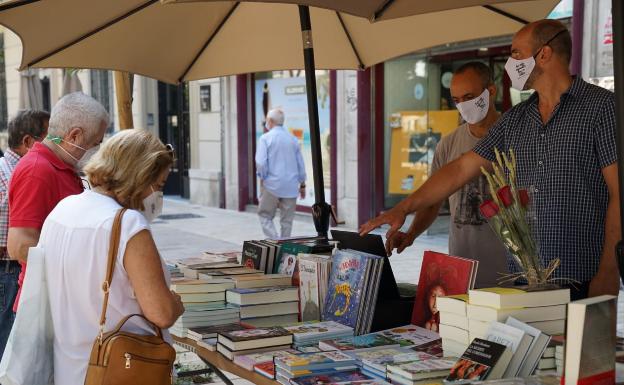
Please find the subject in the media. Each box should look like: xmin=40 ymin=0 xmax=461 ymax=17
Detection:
xmin=172 ymin=335 xmax=280 ymax=385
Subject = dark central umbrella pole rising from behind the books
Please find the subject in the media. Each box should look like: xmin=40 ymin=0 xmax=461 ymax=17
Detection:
xmin=299 ymin=5 xmax=331 ymax=237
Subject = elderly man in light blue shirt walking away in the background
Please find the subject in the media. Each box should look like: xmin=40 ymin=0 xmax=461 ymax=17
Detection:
xmin=256 ymin=109 xmax=306 ymax=239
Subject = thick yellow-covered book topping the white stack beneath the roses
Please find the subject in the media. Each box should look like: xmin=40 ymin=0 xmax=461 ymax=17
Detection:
xmin=468 ymin=287 xmax=570 ymax=309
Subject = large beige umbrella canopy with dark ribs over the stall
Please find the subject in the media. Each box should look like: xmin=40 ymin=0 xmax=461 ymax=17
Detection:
xmin=0 ymin=0 xmax=558 ymax=83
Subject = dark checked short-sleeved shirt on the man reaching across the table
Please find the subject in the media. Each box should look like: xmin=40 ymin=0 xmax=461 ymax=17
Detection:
xmin=474 ymin=77 xmax=617 ymax=282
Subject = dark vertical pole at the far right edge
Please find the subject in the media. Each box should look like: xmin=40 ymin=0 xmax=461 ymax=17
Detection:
xmin=611 ymin=0 xmax=624 ymax=279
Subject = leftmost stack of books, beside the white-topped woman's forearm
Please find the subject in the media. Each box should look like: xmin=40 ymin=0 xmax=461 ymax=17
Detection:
xmin=170 ymin=279 xmax=240 ymax=338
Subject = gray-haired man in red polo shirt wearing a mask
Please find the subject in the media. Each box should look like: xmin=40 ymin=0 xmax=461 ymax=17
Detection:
xmin=7 ymin=92 xmax=109 ymax=311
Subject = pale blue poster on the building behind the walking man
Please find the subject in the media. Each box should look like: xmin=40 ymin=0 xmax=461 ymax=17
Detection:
xmin=255 ymin=73 xmax=331 ymax=207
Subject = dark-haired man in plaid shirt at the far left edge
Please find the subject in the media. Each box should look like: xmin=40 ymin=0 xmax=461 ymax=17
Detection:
xmin=0 ymin=110 xmax=50 ymax=358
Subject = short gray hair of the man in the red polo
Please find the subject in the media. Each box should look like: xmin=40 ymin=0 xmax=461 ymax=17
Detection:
xmin=48 ymin=92 xmax=109 ymax=138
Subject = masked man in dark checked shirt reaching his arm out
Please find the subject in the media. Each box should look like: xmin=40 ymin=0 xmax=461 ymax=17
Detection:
xmin=360 ymin=20 xmax=621 ymax=300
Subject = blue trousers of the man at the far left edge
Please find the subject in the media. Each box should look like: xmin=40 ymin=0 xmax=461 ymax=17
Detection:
xmin=0 ymin=261 xmax=21 ymax=358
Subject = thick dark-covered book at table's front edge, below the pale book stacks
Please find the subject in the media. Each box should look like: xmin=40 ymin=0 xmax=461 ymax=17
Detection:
xmin=218 ymin=327 xmax=292 ymax=350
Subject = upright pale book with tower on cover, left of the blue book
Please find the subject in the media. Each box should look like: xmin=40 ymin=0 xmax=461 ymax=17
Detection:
xmin=298 ymin=254 xmax=332 ymax=322
